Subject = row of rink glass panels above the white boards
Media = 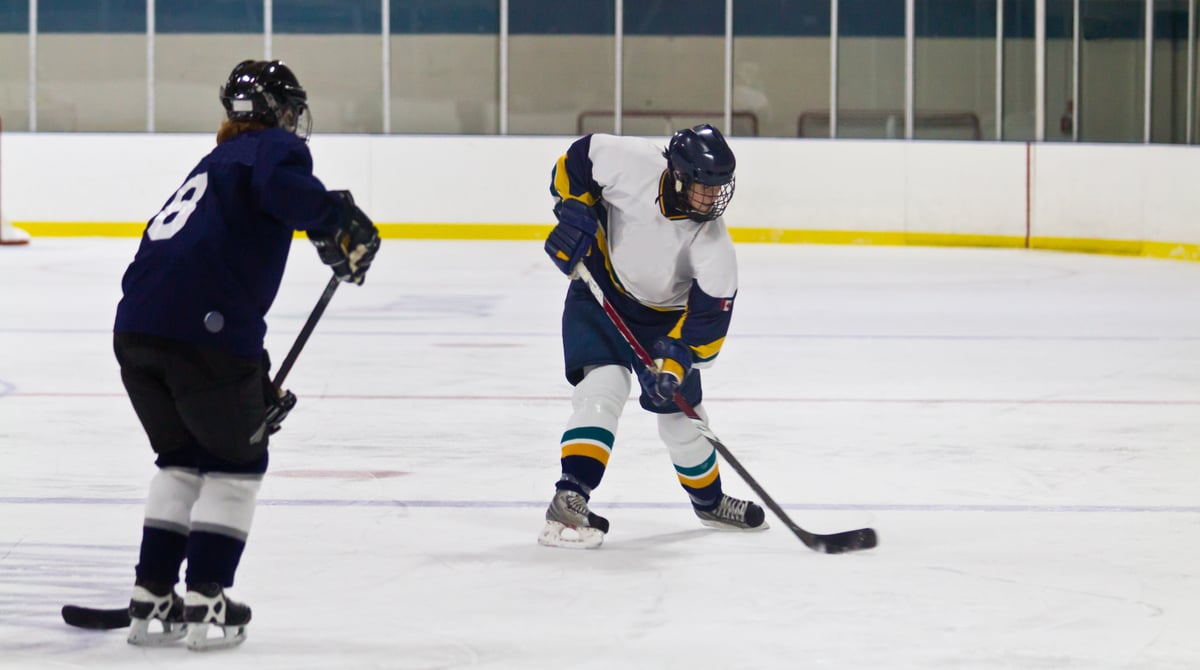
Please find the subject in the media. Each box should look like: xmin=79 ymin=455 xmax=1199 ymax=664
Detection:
xmin=0 ymin=0 xmax=1200 ymax=143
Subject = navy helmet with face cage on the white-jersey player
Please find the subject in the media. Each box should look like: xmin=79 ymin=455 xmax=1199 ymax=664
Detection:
xmin=662 ymin=124 xmax=737 ymax=222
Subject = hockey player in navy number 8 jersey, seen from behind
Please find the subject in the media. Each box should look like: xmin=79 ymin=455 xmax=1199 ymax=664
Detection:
xmin=113 ymin=60 xmax=379 ymax=650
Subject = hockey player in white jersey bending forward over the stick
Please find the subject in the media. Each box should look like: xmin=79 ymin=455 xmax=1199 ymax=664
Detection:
xmin=539 ymin=124 xmax=767 ymax=549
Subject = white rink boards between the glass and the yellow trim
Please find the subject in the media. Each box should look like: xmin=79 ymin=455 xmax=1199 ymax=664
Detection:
xmin=0 ymin=133 xmax=1200 ymax=243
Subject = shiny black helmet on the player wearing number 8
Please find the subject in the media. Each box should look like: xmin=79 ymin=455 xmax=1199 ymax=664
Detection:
xmin=221 ymin=60 xmax=312 ymax=139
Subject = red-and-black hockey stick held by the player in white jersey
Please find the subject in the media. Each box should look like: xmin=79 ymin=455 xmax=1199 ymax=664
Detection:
xmin=572 ymin=261 xmax=878 ymax=554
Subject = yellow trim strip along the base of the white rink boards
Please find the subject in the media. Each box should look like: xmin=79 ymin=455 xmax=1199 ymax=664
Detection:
xmin=12 ymin=221 xmax=1200 ymax=262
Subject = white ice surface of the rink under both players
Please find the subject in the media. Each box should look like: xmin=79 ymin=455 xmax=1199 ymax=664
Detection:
xmin=0 ymin=239 xmax=1200 ymax=670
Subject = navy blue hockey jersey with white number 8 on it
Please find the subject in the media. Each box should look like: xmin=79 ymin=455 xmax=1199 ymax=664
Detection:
xmin=114 ymin=128 xmax=342 ymax=360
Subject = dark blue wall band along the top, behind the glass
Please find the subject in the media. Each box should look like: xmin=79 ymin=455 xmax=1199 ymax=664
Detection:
xmin=23 ymin=0 xmax=1187 ymax=40
